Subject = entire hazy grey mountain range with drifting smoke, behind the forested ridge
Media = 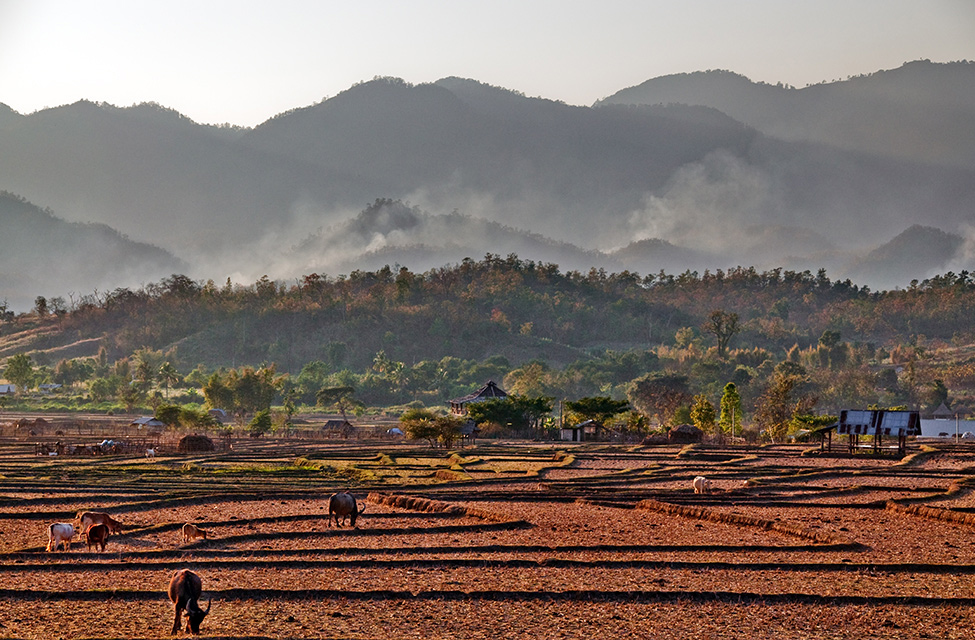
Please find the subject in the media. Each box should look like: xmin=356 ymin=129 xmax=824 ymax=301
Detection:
xmin=0 ymin=61 xmax=975 ymax=307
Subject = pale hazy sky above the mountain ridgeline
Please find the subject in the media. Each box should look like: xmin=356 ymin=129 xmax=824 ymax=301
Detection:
xmin=0 ymin=0 xmax=975 ymax=126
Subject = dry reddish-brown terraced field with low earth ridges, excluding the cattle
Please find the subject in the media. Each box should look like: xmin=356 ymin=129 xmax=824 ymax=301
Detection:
xmin=0 ymin=440 xmax=975 ymax=640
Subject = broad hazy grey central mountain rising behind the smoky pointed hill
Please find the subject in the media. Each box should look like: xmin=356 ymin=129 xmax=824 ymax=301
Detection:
xmin=241 ymin=79 xmax=754 ymax=243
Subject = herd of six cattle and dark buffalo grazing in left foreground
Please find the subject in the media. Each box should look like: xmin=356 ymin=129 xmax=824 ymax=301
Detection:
xmin=38 ymin=491 xmax=366 ymax=635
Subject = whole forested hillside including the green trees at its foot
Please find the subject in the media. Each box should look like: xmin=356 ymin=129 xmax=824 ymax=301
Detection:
xmin=0 ymin=250 xmax=975 ymax=436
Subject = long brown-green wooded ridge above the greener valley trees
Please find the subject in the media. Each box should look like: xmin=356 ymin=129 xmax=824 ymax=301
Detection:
xmin=13 ymin=255 xmax=975 ymax=372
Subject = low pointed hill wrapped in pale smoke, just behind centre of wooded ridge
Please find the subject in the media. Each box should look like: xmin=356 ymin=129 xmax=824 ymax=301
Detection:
xmin=272 ymin=199 xmax=621 ymax=277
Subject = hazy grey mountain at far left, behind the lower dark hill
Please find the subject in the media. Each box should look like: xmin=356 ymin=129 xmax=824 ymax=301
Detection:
xmin=0 ymin=101 xmax=338 ymax=253
